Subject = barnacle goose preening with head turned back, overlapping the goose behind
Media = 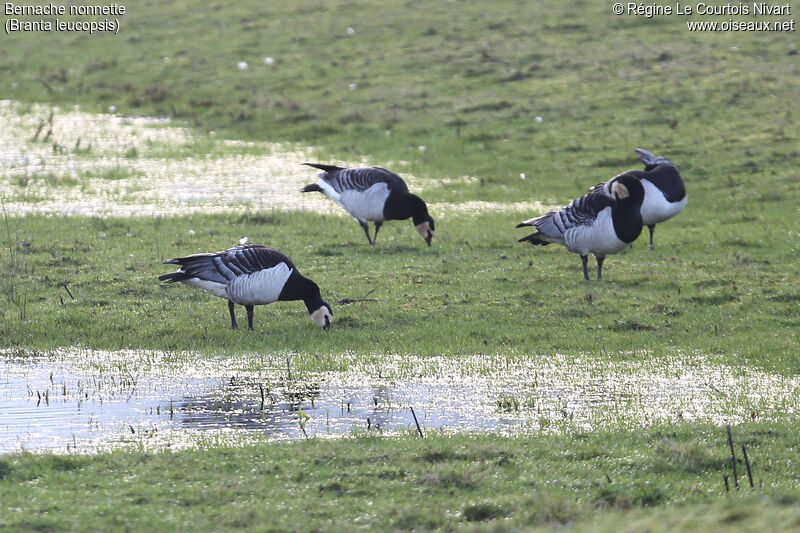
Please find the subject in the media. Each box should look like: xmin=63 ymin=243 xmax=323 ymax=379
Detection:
xmin=517 ymin=175 xmax=644 ymax=280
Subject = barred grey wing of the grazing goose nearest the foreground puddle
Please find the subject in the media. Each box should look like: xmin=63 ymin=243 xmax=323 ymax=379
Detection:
xmin=158 ymin=244 xmax=294 ymax=284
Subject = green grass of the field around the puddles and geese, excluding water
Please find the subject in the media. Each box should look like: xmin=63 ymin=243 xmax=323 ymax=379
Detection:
xmin=0 ymin=0 xmax=800 ymax=531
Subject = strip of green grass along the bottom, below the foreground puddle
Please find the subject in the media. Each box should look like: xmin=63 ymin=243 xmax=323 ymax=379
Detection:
xmin=0 ymin=421 xmax=800 ymax=531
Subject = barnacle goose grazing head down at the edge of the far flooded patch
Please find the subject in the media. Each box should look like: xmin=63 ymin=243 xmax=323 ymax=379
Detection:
xmin=301 ymin=163 xmax=433 ymax=246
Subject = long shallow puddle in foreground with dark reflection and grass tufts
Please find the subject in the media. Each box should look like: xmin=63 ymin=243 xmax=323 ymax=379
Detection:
xmin=0 ymin=349 xmax=800 ymax=453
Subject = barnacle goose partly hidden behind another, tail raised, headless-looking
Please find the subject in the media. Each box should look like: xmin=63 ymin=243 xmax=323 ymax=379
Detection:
xmin=591 ymin=148 xmax=687 ymax=250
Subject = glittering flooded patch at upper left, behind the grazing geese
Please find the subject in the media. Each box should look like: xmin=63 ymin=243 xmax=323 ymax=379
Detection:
xmin=0 ymin=100 xmax=547 ymax=217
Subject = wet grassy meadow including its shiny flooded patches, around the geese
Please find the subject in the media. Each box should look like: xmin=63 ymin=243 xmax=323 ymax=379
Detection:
xmin=0 ymin=1 xmax=800 ymax=531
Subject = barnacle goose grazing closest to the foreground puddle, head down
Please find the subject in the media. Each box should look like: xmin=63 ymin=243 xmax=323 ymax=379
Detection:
xmin=158 ymin=244 xmax=333 ymax=329
